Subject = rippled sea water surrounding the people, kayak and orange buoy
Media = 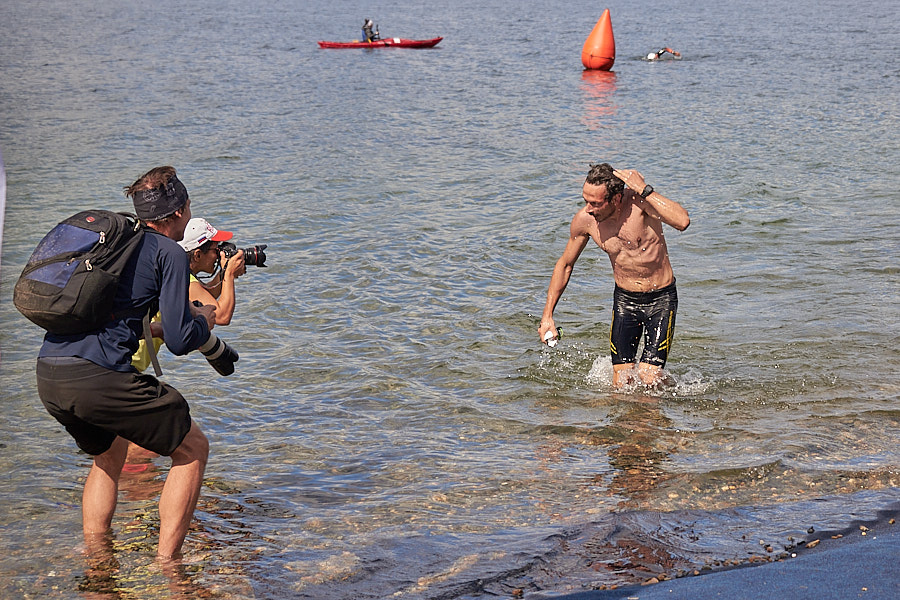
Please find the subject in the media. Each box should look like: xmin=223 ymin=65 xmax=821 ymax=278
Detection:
xmin=0 ymin=0 xmax=900 ymax=599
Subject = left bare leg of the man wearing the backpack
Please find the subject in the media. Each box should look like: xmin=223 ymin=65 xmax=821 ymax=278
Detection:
xmin=81 ymin=437 xmax=128 ymax=547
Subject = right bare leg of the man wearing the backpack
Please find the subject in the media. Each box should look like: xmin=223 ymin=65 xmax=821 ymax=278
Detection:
xmin=157 ymin=422 xmax=209 ymax=558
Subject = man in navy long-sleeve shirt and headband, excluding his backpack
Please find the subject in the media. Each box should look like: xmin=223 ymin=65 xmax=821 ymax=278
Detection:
xmin=37 ymin=167 xmax=221 ymax=558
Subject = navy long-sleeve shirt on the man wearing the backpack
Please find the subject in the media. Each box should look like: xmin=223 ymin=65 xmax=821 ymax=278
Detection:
xmin=38 ymin=230 xmax=209 ymax=372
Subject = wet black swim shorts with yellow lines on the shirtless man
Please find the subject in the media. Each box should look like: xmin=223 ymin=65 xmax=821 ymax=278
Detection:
xmin=609 ymin=281 xmax=678 ymax=367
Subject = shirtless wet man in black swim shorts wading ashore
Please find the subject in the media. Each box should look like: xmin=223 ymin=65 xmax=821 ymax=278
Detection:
xmin=538 ymin=163 xmax=691 ymax=387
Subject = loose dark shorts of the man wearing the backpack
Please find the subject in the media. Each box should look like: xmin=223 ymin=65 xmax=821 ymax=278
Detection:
xmin=37 ymin=357 xmax=191 ymax=456
